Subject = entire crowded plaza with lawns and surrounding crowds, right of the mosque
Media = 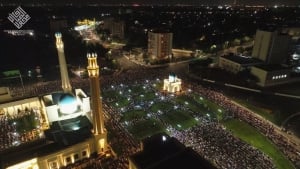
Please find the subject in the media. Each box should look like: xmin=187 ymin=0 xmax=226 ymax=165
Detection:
xmin=1 ymin=69 xmax=299 ymax=168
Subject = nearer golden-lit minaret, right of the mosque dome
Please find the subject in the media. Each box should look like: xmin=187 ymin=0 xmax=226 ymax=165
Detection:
xmin=87 ymin=53 xmax=107 ymax=153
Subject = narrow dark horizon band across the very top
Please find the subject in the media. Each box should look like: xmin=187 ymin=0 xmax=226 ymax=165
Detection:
xmin=0 ymin=0 xmax=300 ymax=6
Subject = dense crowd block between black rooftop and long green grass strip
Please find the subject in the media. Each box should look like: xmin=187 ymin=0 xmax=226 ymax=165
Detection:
xmin=170 ymin=120 xmax=275 ymax=169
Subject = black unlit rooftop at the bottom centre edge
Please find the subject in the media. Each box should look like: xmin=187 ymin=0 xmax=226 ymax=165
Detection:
xmin=130 ymin=133 xmax=216 ymax=169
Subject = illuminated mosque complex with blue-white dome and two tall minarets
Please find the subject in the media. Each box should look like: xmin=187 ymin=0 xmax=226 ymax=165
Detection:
xmin=0 ymin=33 xmax=111 ymax=169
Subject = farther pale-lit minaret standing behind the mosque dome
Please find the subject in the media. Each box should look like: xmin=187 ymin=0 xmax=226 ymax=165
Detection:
xmin=55 ymin=32 xmax=72 ymax=93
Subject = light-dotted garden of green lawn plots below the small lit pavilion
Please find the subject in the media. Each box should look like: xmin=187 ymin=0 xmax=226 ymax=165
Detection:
xmin=102 ymin=79 xmax=227 ymax=140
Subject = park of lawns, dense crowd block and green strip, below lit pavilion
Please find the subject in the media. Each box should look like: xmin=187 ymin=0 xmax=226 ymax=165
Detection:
xmin=102 ymin=79 xmax=293 ymax=169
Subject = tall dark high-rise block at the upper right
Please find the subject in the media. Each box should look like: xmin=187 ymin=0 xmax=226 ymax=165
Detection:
xmin=252 ymin=30 xmax=291 ymax=64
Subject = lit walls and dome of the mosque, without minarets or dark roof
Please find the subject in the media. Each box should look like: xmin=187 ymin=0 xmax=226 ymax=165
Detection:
xmin=0 ymin=89 xmax=98 ymax=169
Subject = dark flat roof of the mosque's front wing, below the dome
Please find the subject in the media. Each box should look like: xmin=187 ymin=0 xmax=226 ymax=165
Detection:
xmin=0 ymin=117 xmax=92 ymax=168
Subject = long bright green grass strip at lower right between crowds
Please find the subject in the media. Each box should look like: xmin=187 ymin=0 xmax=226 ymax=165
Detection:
xmin=223 ymin=119 xmax=294 ymax=169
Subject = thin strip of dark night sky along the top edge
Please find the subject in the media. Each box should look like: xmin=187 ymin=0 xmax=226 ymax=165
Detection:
xmin=0 ymin=0 xmax=300 ymax=5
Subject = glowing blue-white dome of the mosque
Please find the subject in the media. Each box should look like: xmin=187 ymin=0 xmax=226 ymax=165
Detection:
xmin=58 ymin=93 xmax=78 ymax=114
